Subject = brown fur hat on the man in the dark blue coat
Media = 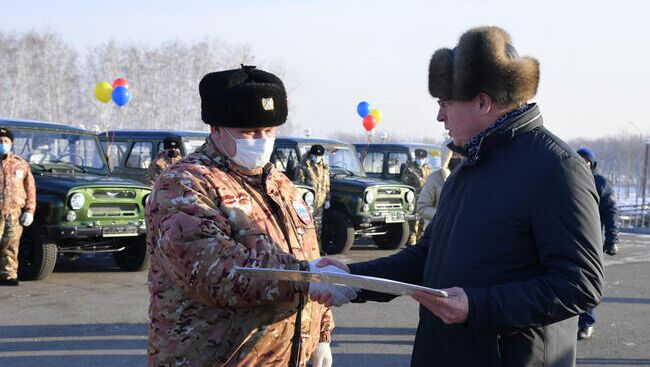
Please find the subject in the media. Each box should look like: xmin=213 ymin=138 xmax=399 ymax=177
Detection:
xmin=429 ymin=27 xmax=539 ymax=106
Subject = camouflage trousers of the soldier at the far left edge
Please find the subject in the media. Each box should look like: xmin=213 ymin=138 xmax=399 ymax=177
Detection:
xmin=0 ymin=214 xmax=23 ymax=280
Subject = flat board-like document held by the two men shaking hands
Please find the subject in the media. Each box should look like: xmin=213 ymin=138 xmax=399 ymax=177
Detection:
xmin=235 ymin=266 xmax=448 ymax=297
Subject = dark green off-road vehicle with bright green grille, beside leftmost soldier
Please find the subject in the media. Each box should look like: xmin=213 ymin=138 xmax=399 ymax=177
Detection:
xmin=0 ymin=119 xmax=150 ymax=279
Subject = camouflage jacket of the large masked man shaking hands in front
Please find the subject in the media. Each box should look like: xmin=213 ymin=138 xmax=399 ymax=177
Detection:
xmin=147 ymin=140 xmax=334 ymax=367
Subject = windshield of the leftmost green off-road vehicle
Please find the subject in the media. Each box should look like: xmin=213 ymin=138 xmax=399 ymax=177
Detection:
xmin=12 ymin=128 xmax=109 ymax=174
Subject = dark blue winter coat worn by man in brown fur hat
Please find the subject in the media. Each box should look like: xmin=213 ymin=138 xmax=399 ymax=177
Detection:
xmin=350 ymin=106 xmax=603 ymax=367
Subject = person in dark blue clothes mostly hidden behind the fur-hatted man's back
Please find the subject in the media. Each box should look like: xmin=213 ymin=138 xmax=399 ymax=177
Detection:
xmin=578 ymin=148 xmax=618 ymax=340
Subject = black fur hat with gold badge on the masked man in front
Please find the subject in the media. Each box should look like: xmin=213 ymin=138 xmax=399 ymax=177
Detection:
xmin=199 ymin=65 xmax=288 ymax=127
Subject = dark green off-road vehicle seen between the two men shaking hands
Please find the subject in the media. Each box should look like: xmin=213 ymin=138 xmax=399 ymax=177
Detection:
xmin=271 ymin=137 xmax=416 ymax=254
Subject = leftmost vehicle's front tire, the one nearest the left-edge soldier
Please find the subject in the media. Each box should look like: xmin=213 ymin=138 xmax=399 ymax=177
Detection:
xmin=18 ymin=231 xmax=57 ymax=280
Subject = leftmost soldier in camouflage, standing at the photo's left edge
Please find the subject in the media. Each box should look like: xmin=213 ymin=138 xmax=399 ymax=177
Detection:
xmin=0 ymin=127 xmax=36 ymax=285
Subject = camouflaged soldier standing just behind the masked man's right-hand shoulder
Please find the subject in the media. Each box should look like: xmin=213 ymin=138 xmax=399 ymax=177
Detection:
xmin=296 ymin=144 xmax=330 ymax=243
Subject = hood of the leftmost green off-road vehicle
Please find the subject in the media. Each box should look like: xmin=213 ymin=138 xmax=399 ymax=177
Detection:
xmin=34 ymin=173 xmax=149 ymax=194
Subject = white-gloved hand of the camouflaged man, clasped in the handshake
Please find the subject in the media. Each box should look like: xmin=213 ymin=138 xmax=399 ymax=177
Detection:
xmin=309 ymin=258 xmax=357 ymax=307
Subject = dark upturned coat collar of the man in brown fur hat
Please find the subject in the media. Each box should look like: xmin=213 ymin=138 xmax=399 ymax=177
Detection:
xmin=447 ymin=103 xmax=543 ymax=165
